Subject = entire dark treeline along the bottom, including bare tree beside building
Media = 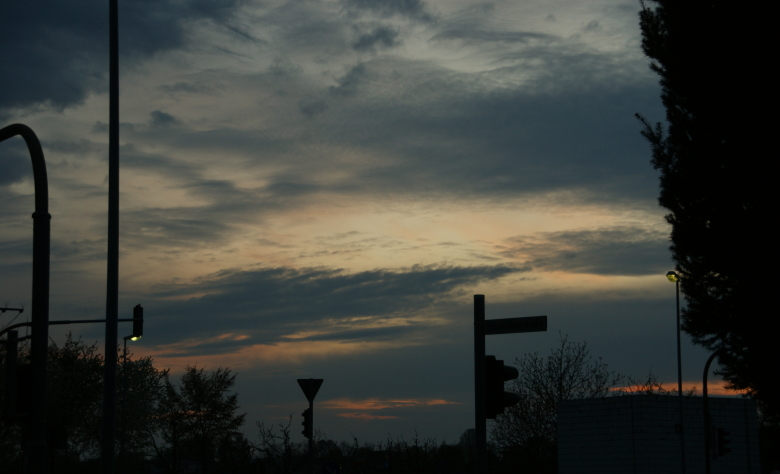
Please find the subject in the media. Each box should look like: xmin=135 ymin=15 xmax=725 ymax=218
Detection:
xmin=0 ymin=335 xmax=776 ymax=474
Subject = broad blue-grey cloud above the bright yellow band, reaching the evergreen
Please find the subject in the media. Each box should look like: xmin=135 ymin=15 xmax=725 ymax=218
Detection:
xmin=111 ymin=59 xmax=658 ymax=210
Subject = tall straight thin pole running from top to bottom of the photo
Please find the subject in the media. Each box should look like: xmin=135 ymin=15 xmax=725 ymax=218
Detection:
xmin=102 ymin=0 xmax=119 ymax=474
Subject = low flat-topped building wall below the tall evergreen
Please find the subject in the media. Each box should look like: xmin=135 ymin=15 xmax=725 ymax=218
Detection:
xmin=558 ymin=395 xmax=759 ymax=474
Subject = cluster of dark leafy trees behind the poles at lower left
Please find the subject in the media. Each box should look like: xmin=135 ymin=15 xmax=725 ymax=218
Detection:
xmin=0 ymin=334 xmax=247 ymax=474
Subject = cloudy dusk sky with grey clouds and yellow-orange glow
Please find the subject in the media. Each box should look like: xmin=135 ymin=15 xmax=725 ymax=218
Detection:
xmin=0 ymin=0 xmax=736 ymax=442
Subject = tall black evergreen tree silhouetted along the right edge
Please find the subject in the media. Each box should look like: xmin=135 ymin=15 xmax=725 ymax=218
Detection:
xmin=640 ymin=0 xmax=780 ymax=416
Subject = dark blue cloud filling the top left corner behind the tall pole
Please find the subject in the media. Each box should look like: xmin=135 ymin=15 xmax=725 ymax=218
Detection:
xmin=0 ymin=0 xmax=241 ymax=117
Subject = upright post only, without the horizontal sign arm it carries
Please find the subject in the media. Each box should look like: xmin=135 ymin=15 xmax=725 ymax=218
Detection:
xmin=474 ymin=295 xmax=487 ymax=474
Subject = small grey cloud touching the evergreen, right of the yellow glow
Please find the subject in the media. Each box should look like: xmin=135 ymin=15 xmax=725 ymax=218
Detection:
xmin=501 ymin=226 xmax=671 ymax=276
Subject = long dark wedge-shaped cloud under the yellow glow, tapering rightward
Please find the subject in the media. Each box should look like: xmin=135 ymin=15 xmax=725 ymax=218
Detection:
xmin=143 ymin=265 xmax=527 ymax=351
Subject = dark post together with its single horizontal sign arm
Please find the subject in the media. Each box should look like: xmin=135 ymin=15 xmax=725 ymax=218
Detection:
xmin=474 ymin=295 xmax=547 ymax=474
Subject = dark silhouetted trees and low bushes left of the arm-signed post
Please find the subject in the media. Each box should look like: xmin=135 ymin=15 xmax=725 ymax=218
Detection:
xmin=0 ymin=335 xmax=532 ymax=474
